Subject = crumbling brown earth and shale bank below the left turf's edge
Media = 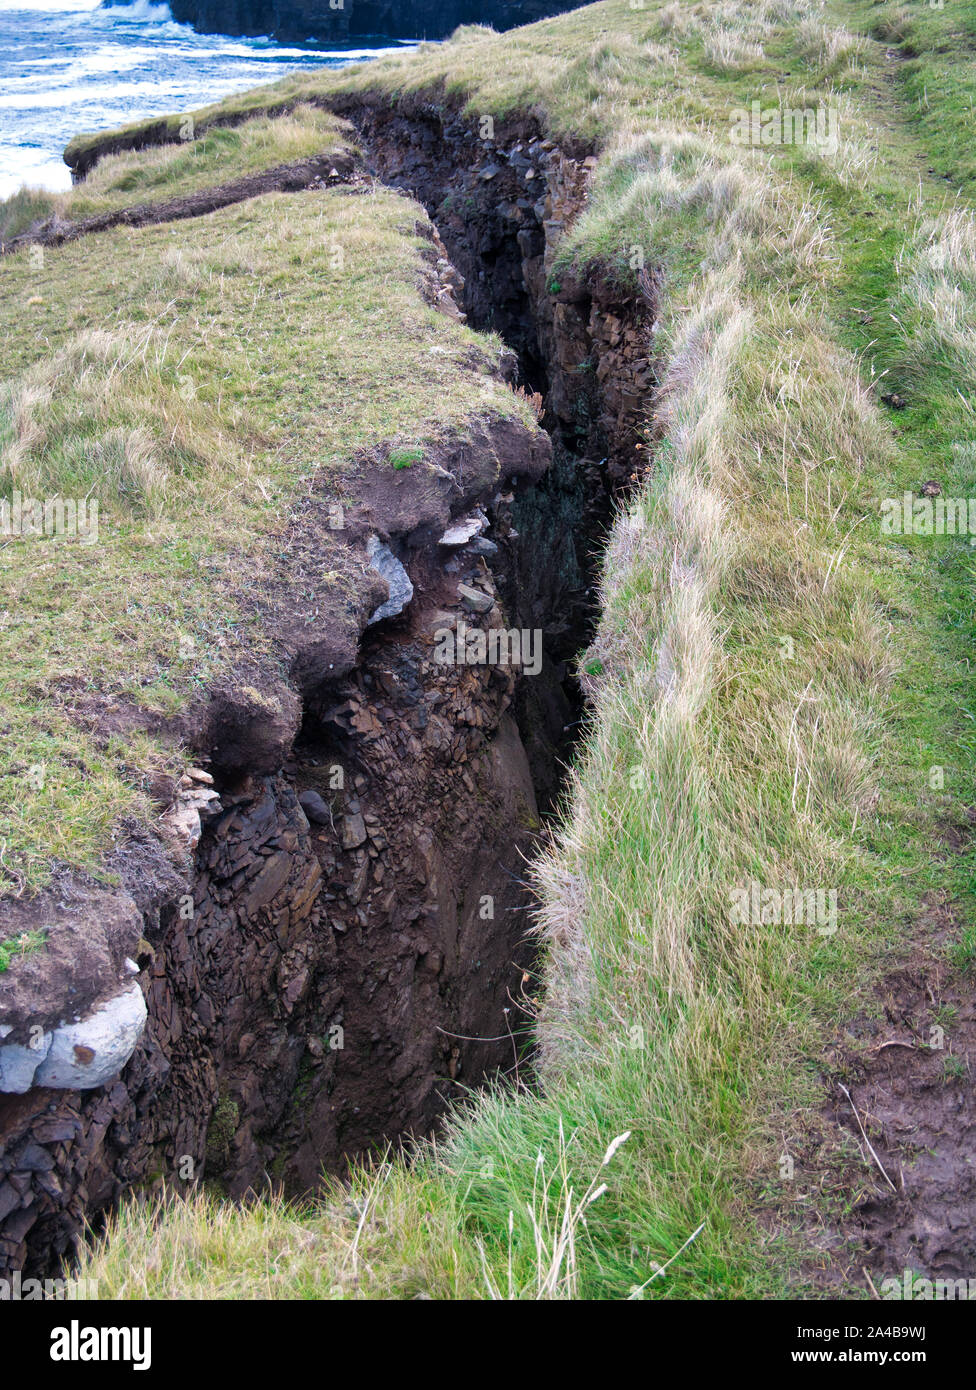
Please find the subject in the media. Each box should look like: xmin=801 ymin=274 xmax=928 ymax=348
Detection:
xmin=0 ymin=405 xmax=549 ymax=1269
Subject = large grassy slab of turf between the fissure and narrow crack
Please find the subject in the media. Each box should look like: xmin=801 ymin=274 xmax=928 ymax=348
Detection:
xmin=0 ymin=176 xmax=524 ymax=891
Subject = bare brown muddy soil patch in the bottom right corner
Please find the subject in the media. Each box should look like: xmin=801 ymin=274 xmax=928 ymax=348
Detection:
xmin=801 ymin=884 xmax=976 ymax=1298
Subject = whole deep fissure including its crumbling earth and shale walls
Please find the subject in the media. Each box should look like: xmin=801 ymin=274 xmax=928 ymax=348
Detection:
xmin=0 ymin=95 xmax=652 ymax=1270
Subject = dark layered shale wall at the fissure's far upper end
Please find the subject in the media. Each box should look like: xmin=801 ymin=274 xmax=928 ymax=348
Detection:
xmin=330 ymin=93 xmax=655 ymax=488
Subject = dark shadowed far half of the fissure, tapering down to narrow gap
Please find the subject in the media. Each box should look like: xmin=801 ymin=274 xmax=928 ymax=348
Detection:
xmin=330 ymin=93 xmax=656 ymax=812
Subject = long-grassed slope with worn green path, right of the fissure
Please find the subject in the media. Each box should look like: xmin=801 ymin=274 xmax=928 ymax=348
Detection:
xmin=51 ymin=0 xmax=976 ymax=1297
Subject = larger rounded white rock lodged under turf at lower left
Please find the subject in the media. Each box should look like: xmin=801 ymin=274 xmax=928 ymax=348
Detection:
xmin=33 ymin=984 xmax=146 ymax=1091
